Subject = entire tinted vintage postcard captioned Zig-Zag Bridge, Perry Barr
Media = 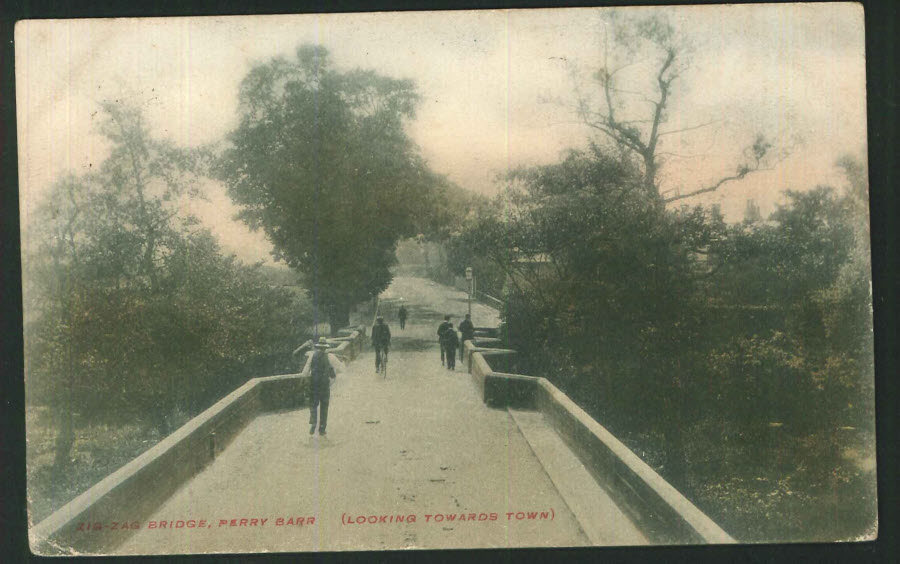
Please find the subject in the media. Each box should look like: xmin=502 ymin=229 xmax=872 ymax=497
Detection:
xmin=15 ymin=3 xmax=878 ymax=555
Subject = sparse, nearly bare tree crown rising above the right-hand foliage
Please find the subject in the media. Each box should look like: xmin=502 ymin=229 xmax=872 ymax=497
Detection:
xmin=575 ymin=12 xmax=784 ymax=204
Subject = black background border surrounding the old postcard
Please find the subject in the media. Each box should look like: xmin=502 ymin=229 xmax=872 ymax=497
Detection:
xmin=0 ymin=0 xmax=900 ymax=562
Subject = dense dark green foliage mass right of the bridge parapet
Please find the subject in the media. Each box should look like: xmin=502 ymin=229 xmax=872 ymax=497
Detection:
xmin=452 ymin=146 xmax=874 ymax=538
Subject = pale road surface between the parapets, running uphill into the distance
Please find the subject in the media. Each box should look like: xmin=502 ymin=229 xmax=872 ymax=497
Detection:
xmin=116 ymin=278 xmax=589 ymax=554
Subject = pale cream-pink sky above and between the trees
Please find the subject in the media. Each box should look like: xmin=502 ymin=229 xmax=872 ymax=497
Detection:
xmin=15 ymin=3 xmax=866 ymax=262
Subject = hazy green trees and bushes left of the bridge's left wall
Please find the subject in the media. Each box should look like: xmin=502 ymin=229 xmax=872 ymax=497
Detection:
xmin=24 ymin=104 xmax=304 ymax=476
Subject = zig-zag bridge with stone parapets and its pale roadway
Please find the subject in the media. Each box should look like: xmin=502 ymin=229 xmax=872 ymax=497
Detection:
xmin=30 ymin=276 xmax=734 ymax=555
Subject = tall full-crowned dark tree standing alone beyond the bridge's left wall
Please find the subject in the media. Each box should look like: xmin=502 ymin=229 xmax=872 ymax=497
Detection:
xmin=218 ymin=45 xmax=434 ymax=331
